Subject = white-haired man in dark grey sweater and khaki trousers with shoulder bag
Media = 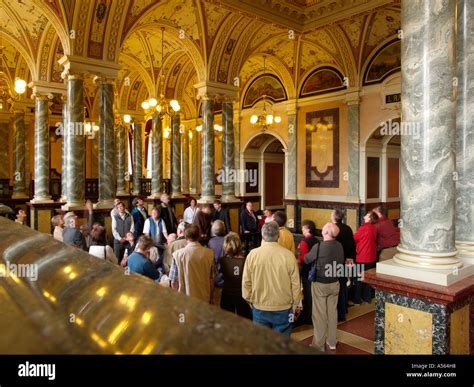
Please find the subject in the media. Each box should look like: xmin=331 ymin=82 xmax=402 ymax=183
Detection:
xmin=304 ymin=223 xmax=344 ymax=351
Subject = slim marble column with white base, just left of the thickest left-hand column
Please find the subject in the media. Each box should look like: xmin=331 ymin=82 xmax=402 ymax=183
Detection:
xmin=31 ymin=94 xmax=53 ymax=203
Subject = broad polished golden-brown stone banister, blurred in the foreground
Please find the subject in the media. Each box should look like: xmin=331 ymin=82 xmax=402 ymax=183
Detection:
xmin=0 ymin=217 xmax=315 ymax=354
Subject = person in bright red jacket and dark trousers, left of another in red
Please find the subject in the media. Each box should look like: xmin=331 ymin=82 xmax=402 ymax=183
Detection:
xmin=354 ymin=211 xmax=378 ymax=305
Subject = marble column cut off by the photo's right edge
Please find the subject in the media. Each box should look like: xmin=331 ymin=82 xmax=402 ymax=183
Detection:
xmin=456 ymin=0 xmax=474 ymax=264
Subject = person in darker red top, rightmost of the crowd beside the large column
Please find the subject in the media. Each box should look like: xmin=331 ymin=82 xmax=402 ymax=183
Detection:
xmin=373 ymin=206 xmax=400 ymax=261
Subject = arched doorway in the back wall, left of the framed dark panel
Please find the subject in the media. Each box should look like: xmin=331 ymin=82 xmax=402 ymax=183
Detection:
xmin=241 ymin=132 xmax=286 ymax=210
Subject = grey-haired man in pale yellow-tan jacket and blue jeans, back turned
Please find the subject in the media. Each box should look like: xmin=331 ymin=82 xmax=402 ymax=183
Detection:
xmin=242 ymin=222 xmax=301 ymax=336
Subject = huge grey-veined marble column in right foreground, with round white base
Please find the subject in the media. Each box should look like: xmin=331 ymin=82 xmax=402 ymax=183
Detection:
xmin=392 ymin=0 xmax=462 ymax=272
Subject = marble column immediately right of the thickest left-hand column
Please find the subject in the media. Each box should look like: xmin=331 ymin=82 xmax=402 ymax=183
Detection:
xmin=95 ymin=81 xmax=115 ymax=208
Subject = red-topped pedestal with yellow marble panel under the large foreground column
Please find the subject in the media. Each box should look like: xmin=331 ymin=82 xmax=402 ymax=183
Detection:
xmin=364 ymin=269 xmax=474 ymax=355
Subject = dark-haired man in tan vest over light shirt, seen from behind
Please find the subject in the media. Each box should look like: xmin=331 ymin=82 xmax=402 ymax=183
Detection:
xmin=169 ymin=225 xmax=215 ymax=303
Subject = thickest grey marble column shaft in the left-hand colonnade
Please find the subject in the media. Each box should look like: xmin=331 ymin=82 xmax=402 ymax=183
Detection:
xmin=63 ymin=74 xmax=86 ymax=211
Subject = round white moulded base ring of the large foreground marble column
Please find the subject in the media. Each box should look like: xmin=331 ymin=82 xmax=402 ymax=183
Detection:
xmin=393 ymin=246 xmax=462 ymax=270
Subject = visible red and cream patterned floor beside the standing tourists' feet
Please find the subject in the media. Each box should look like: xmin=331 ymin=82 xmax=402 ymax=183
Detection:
xmin=291 ymin=300 xmax=375 ymax=355
